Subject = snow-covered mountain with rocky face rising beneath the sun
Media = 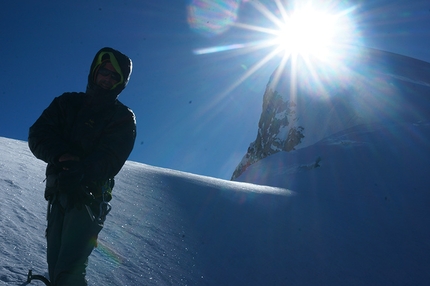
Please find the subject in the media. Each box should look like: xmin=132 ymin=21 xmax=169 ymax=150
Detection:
xmin=232 ymin=48 xmax=430 ymax=180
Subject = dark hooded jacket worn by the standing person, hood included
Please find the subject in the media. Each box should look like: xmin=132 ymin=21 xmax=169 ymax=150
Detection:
xmin=28 ymin=48 xmax=136 ymax=199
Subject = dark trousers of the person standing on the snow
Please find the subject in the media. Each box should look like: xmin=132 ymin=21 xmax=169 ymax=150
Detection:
xmin=46 ymin=195 xmax=103 ymax=286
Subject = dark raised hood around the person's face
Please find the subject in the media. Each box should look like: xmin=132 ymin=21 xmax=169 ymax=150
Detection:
xmin=87 ymin=47 xmax=132 ymax=103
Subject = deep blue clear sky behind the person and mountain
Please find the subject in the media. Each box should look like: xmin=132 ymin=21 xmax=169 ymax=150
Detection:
xmin=0 ymin=0 xmax=430 ymax=179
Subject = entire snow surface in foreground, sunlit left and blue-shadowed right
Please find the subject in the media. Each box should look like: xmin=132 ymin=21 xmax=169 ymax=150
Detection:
xmin=0 ymin=118 xmax=430 ymax=285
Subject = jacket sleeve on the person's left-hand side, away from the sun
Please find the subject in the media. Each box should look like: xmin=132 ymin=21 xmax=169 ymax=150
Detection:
xmin=28 ymin=96 xmax=69 ymax=164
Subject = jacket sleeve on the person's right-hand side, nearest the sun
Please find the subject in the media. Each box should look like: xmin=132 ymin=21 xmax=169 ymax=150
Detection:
xmin=84 ymin=106 xmax=136 ymax=181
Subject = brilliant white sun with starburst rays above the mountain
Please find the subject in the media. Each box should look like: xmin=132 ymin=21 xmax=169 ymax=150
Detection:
xmin=194 ymin=0 xmax=357 ymax=96
